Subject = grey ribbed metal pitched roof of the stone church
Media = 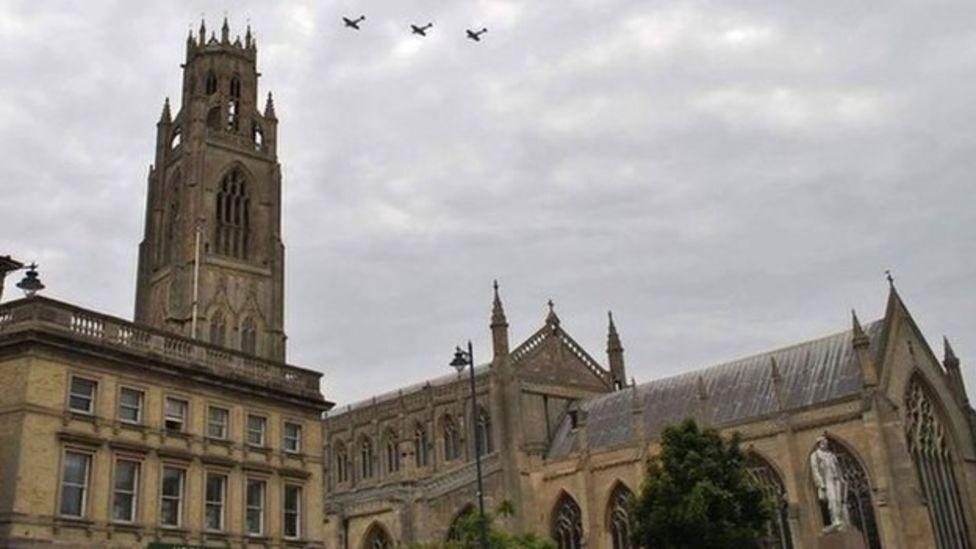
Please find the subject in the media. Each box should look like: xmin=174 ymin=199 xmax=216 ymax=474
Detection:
xmin=548 ymin=320 xmax=885 ymax=459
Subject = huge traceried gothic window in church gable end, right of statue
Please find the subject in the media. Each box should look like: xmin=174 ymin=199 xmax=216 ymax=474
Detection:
xmin=905 ymin=374 xmax=971 ymax=549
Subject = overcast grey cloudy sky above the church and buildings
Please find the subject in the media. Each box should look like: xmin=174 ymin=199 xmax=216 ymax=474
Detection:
xmin=0 ymin=0 xmax=976 ymax=404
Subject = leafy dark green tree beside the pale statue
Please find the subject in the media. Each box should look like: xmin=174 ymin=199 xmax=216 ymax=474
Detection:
xmin=633 ymin=419 xmax=773 ymax=549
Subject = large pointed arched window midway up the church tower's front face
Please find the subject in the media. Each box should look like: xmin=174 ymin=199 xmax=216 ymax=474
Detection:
xmin=214 ymin=168 xmax=251 ymax=259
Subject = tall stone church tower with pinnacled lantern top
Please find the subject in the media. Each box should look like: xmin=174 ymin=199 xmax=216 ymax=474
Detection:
xmin=135 ymin=18 xmax=285 ymax=361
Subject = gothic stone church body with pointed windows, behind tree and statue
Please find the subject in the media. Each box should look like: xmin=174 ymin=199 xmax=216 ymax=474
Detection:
xmin=325 ymin=286 xmax=976 ymax=549
